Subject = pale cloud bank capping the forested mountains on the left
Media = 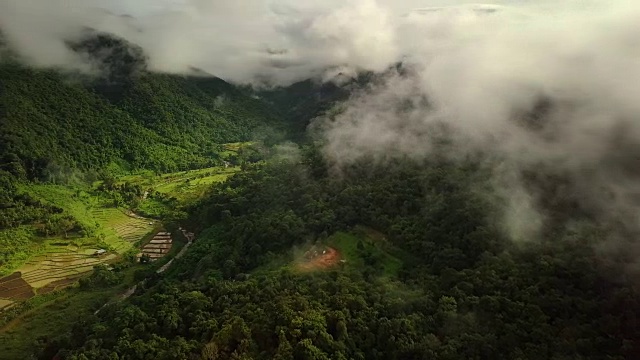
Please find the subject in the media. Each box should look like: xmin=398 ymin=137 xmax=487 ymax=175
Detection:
xmin=0 ymin=0 xmax=398 ymax=84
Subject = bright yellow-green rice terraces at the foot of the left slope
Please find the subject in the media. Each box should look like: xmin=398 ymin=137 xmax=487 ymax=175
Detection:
xmin=0 ymin=147 xmax=248 ymax=311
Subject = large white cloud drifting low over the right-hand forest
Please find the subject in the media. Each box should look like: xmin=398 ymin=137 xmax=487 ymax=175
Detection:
xmin=313 ymin=1 xmax=640 ymax=253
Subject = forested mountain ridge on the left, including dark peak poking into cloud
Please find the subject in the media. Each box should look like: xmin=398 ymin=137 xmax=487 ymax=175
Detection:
xmin=0 ymin=30 xmax=289 ymax=271
